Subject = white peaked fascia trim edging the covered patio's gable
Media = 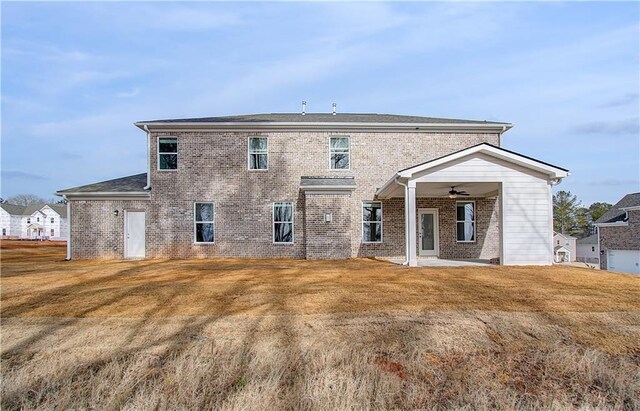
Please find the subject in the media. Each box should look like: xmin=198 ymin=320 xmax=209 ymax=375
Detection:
xmin=399 ymin=145 xmax=569 ymax=178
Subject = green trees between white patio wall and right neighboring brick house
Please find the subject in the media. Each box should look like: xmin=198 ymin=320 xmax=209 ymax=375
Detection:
xmin=553 ymin=191 xmax=612 ymax=238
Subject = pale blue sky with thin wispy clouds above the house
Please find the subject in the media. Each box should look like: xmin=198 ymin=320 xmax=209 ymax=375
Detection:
xmin=1 ymin=2 xmax=640 ymax=205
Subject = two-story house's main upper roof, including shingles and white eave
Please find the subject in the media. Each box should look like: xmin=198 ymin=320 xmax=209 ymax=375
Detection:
xmin=135 ymin=113 xmax=513 ymax=131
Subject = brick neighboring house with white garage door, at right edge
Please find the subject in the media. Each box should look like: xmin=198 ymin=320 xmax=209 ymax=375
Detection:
xmin=595 ymin=193 xmax=640 ymax=274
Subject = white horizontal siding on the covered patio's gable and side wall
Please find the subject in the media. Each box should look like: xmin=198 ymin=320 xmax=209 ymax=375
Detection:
xmin=415 ymin=153 xmax=553 ymax=265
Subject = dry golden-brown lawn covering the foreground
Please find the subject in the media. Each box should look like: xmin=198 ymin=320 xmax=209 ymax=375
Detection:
xmin=0 ymin=241 xmax=640 ymax=409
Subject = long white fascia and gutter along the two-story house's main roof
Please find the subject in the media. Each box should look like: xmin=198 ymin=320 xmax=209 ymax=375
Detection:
xmin=134 ymin=121 xmax=513 ymax=133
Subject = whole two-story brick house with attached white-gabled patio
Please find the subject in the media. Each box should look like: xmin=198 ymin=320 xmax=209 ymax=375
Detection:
xmin=56 ymin=113 xmax=568 ymax=266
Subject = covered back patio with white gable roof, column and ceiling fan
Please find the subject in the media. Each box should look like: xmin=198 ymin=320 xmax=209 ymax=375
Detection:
xmin=376 ymin=143 xmax=568 ymax=266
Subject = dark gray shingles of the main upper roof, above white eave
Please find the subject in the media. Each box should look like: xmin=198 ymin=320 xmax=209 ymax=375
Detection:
xmin=136 ymin=113 xmax=511 ymax=126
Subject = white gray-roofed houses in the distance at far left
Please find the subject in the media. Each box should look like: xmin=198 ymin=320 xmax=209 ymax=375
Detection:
xmin=0 ymin=204 xmax=68 ymax=240
